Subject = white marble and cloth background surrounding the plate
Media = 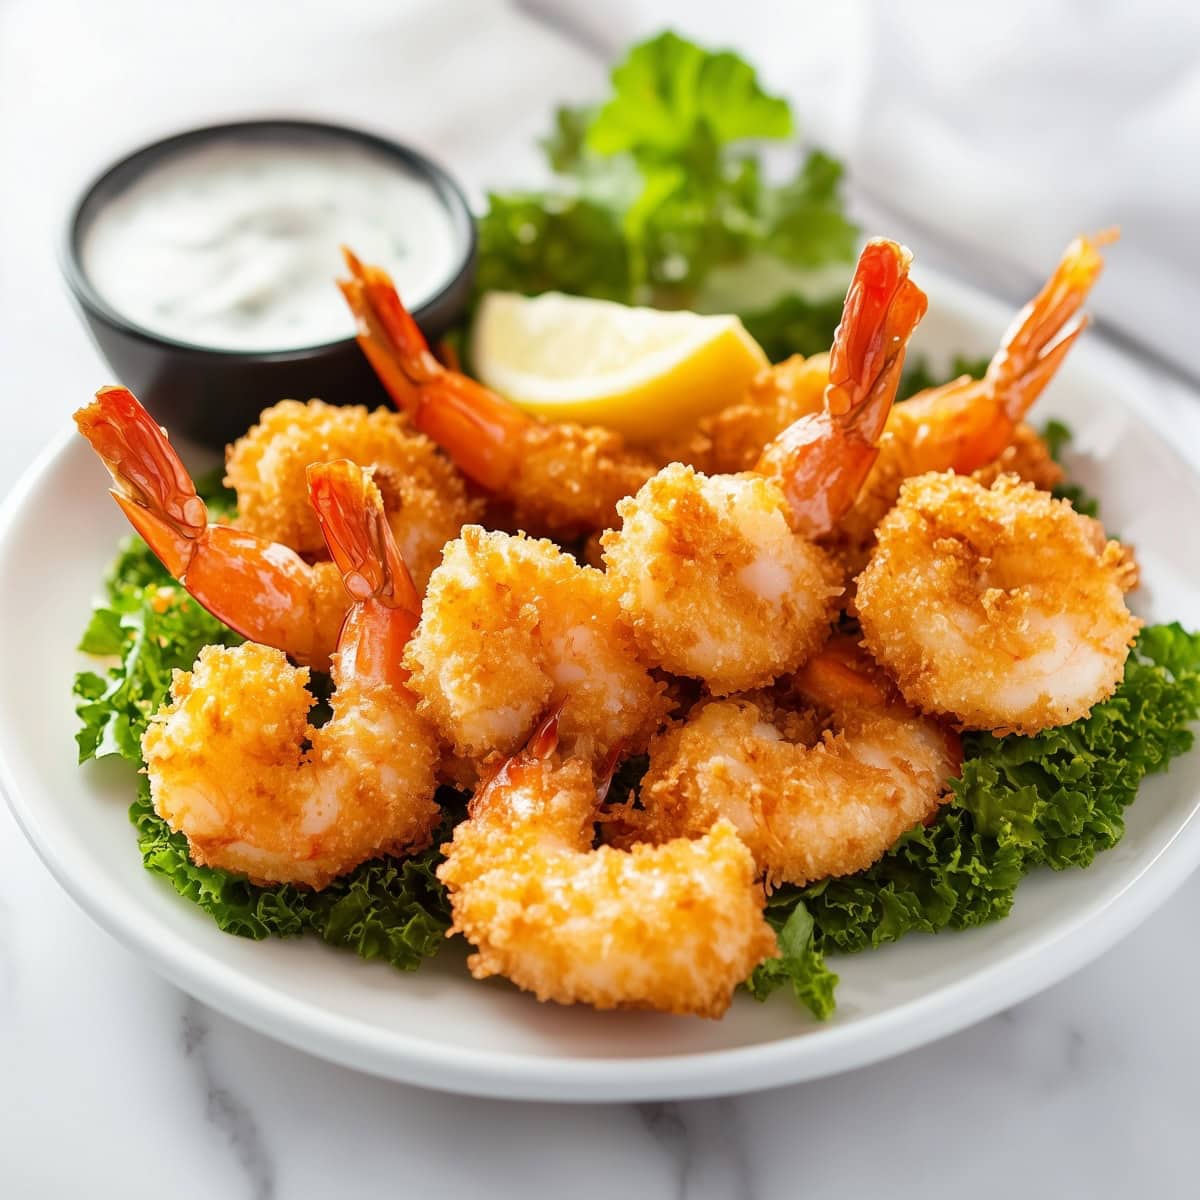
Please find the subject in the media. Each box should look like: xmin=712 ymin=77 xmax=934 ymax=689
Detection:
xmin=0 ymin=0 xmax=1200 ymax=1200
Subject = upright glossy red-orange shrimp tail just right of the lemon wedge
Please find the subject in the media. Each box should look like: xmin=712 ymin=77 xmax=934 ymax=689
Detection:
xmin=755 ymin=238 xmax=928 ymax=538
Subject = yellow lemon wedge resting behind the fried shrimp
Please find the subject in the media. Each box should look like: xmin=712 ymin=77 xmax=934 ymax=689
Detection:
xmin=470 ymin=292 xmax=767 ymax=442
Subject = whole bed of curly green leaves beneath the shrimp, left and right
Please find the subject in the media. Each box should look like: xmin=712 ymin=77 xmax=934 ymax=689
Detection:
xmin=76 ymin=516 xmax=1200 ymax=1018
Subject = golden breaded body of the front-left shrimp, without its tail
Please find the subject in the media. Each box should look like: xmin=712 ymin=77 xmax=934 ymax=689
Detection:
xmin=142 ymin=642 xmax=439 ymax=888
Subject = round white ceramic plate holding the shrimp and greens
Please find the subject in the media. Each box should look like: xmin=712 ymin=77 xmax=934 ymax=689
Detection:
xmin=0 ymin=274 xmax=1200 ymax=1100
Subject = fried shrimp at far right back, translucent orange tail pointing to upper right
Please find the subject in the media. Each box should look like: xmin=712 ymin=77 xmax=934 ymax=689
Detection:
xmin=829 ymin=233 xmax=1116 ymax=574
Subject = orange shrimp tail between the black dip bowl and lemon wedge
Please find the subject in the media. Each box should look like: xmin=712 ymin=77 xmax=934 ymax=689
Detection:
xmin=337 ymin=246 xmax=532 ymax=492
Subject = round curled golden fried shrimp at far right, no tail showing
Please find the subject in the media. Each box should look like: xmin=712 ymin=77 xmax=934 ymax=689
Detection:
xmin=858 ymin=473 xmax=1141 ymax=734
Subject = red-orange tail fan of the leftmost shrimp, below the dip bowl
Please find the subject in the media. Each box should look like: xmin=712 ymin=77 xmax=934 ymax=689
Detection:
xmin=74 ymin=388 xmax=209 ymax=578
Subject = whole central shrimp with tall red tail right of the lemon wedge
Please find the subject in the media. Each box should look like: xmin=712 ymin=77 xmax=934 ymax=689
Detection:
xmin=601 ymin=239 xmax=925 ymax=695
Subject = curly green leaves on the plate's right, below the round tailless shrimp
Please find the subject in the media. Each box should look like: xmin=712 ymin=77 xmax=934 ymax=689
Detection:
xmin=755 ymin=624 xmax=1200 ymax=969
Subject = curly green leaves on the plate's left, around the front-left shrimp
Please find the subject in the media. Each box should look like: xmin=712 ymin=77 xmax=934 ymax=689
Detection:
xmin=74 ymin=506 xmax=453 ymax=971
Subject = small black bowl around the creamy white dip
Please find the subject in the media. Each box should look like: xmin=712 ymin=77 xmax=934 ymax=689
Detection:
xmin=62 ymin=120 xmax=475 ymax=446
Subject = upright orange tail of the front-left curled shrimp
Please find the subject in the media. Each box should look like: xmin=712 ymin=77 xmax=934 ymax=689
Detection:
xmin=307 ymin=458 xmax=421 ymax=688
